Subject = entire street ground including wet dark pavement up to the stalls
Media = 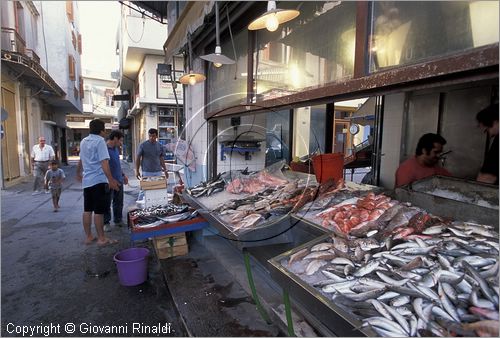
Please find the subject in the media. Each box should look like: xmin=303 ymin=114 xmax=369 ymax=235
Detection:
xmin=1 ymin=161 xmax=280 ymax=336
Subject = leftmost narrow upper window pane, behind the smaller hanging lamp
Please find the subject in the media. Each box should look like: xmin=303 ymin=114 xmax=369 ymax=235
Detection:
xmin=207 ymin=29 xmax=248 ymax=112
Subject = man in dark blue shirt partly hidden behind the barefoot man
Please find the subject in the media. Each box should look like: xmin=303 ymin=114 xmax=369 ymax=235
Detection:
xmin=104 ymin=130 xmax=128 ymax=231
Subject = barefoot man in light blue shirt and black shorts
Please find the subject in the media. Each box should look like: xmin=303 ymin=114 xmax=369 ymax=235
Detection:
xmin=76 ymin=119 xmax=119 ymax=246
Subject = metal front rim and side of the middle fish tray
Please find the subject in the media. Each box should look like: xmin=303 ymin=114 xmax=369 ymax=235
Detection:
xmin=182 ymin=192 xmax=293 ymax=249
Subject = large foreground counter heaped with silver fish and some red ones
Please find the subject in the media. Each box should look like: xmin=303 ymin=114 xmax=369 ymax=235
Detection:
xmin=269 ymin=193 xmax=500 ymax=336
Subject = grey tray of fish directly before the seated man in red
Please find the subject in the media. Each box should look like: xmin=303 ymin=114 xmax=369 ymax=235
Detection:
xmin=395 ymin=176 xmax=499 ymax=231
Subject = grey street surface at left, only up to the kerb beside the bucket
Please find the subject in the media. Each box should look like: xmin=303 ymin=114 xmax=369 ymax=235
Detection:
xmin=1 ymin=162 xmax=186 ymax=336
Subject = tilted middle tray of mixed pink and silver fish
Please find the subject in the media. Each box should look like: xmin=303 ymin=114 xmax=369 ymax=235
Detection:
xmin=183 ymin=163 xmax=334 ymax=248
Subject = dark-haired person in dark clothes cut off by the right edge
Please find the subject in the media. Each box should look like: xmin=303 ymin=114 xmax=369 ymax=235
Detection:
xmin=476 ymin=103 xmax=498 ymax=184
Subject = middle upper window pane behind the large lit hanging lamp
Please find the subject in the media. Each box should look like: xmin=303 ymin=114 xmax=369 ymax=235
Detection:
xmin=253 ymin=1 xmax=356 ymax=102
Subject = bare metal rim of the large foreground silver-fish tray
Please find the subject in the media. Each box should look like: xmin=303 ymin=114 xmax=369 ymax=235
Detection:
xmin=268 ymin=234 xmax=377 ymax=337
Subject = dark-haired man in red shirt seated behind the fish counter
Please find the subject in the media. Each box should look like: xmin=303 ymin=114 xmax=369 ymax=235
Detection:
xmin=395 ymin=133 xmax=451 ymax=187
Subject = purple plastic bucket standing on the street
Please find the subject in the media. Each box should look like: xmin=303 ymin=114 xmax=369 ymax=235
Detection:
xmin=113 ymin=248 xmax=149 ymax=286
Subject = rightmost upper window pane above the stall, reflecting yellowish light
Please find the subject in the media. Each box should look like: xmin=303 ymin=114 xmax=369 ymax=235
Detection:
xmin=369 ymin=1 xmax=499 ymax=72
